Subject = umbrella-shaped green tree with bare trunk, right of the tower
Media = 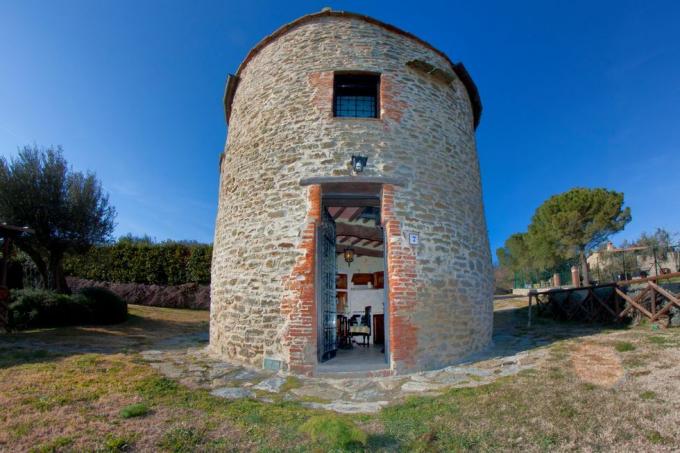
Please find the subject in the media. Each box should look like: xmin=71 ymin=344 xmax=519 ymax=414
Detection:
xmin=529 ymin=188 xmax=631 ymax=284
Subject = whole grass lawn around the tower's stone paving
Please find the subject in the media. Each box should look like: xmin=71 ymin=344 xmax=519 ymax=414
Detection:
xmin=0 ymin=298 xmax=680 ymax=452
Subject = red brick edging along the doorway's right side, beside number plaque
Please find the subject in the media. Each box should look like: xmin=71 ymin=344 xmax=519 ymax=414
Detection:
xmin=382 ymin=184 xmax=418 ymax=371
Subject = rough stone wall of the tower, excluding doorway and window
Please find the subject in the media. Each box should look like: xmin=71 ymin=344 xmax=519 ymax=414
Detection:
xmin=210 ymin=17 xmax=493 ymax=371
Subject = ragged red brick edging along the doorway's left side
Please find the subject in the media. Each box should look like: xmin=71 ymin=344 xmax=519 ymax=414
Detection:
xmin=281 ymin=185 xmax=321 ymax=375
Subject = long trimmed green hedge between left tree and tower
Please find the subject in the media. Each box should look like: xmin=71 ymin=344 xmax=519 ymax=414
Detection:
xmin=64 ymin=241 xmax=212 ymax=285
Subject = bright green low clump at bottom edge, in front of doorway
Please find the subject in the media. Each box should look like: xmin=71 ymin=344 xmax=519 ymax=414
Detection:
xmin=300 ymin=415 xmax=368 ymax=450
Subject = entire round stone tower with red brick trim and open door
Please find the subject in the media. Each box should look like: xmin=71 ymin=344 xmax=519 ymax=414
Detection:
xmin=210 ymin=10 xmax=493 ymax=375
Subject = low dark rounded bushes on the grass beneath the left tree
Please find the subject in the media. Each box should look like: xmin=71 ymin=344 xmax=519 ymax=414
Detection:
xmin=9 ymin=288 xmax=127 ymax=329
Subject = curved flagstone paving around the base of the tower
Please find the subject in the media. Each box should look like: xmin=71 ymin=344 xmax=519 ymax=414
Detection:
xmin=142 ymin=308 xmax=549 ymax=413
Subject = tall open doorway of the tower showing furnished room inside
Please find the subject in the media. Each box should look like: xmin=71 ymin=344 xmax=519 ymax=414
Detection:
xmin=317 ymin=189 xmax=388 ymax=373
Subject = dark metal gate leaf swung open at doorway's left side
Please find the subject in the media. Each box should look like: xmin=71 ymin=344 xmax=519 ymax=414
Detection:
xmin=317 ymin=207 xmax=338 ymax=362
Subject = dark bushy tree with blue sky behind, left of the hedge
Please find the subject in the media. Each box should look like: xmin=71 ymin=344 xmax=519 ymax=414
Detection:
xmin=0 ymin=146 xmax=116 ymax=292
